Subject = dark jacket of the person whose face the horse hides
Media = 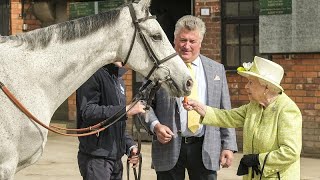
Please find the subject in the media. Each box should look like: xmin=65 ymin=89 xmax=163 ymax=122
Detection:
xmin=76 ymin=64 xmax=135 ymax=160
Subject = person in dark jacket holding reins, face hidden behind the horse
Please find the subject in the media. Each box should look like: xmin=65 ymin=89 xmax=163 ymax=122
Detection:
xmin=76 ymin=63 xmax=144 ymax=180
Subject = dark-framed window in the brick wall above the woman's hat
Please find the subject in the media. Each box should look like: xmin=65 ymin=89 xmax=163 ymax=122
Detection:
xmin=221 ymin=0 xmax=264 ymax=70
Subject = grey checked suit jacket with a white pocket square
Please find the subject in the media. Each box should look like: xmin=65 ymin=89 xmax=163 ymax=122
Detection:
xmin=146 ymin=55 xmax=237 ymax=171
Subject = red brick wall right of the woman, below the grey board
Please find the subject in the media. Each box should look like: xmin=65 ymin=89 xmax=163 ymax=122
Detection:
xmin=273 ymin=54 xmax=320 ymax=157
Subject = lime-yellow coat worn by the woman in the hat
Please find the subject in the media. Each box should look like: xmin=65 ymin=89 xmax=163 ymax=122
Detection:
xmin=202 ymin=93 xmax=302 ymax=180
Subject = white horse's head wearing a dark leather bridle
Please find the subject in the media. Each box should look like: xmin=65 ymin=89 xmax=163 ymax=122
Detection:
xmin=120 ymin=0 xmax=193 ymax=96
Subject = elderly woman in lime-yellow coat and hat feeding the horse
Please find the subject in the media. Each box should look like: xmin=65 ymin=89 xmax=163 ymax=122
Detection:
xmin=184 ymin=56 xmax=302 ymax=180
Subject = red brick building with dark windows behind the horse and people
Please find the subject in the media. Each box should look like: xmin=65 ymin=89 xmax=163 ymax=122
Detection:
xmin=0 ymin=0 xmax=320 ymax=157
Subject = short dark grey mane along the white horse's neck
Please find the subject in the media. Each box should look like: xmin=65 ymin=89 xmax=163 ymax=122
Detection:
xmin=4 ymin=4 xmax=126 ymax=50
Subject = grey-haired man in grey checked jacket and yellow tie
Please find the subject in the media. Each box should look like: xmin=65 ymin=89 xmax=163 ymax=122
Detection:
xmin=146 ymin=15 xmax=237 ymax=180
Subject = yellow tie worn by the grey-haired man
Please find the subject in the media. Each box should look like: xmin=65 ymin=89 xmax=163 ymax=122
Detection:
xmin=186 ymin=63 xmax=200 ymax=133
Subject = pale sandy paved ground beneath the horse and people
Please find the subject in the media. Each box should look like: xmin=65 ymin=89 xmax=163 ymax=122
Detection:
xmin=15 ymin=135 xmax=320 ymax=180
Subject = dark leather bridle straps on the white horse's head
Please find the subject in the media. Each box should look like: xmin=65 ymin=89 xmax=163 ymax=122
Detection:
xmin=123 ymin=3 xmax=177 ymax=79
